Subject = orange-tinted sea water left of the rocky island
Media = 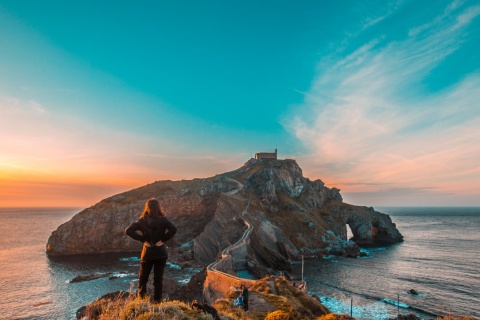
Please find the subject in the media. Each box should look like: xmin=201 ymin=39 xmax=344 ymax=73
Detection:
xmin=0 ymin=208 xmax=198 ymax=320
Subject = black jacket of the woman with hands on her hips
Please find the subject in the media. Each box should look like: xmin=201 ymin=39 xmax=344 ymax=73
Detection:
xmin=125 ymin=216 xmax=177 ymax=261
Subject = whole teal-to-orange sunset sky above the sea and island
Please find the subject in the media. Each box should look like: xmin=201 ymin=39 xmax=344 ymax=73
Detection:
xmin=0 ymin=0 xmax=480 ymax=207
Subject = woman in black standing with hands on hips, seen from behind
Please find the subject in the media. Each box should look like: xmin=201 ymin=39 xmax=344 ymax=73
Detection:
xmin=125 ymin=198 xmax=177 ymax=302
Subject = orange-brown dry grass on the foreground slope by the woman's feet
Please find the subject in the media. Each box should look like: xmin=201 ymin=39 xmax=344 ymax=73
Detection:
xmin=80 ymin=277 xmax=350 ymax=320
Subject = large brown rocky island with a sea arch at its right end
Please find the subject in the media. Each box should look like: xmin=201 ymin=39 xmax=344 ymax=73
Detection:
xmin=47 ymin=159 xmax=403 ymax=276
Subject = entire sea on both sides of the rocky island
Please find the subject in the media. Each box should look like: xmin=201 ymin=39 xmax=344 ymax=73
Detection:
xmin=0 ymin=207 xmax=480 ymax=320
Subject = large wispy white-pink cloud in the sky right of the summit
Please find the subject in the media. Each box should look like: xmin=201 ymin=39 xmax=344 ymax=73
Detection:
xmin=285 ymin=1 xmax=480 ymax=202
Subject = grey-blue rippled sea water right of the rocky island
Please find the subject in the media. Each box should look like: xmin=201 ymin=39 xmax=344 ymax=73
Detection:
xmin=295 ymin=207 xmax=480 ymax=320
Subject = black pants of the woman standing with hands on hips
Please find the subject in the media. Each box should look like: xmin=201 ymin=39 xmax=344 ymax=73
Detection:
xmin=138 ymin=259 xmax=167 ymax=302
